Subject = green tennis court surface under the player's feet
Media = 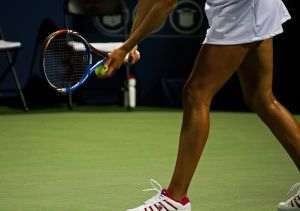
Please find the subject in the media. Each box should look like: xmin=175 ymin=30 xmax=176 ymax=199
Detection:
xmin=0 ymin=107 xmax=299 ymax=211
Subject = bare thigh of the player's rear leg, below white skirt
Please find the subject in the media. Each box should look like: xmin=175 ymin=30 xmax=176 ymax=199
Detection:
xmin=238 ymin=39 xmax=273 ymax=101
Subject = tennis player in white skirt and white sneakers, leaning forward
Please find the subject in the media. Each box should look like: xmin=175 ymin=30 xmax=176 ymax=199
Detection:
xmin=104 ymin=0 xmax=300 ymax=211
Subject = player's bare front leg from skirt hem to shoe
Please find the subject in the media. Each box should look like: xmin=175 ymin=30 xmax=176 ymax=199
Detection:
xmin=168 ymin=44 xmax=253 ymax=200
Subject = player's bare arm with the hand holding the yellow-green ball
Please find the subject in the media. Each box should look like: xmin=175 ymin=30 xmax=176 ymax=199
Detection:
xmin=107 ymin=0 xmax=176 ymax=75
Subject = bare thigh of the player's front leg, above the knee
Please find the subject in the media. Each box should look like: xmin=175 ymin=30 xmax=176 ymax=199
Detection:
xmin=185 ymin=44 xmax=252 ymax=97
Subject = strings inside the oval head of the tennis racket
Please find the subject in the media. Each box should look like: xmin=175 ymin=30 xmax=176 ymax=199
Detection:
xmin=44 ymin=34 xmax=90 ymax=88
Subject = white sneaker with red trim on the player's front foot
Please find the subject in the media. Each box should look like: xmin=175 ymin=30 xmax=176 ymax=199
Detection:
xmin=127 ymin=179 xmax=191 ymax=211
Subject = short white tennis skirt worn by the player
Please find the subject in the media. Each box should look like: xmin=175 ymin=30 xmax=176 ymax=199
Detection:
xmin=204 ymin=0 xmax=291 ymax=45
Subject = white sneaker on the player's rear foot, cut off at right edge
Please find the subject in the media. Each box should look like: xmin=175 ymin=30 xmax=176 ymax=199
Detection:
xmin=278 ymin=183 xmax=300 ymax=211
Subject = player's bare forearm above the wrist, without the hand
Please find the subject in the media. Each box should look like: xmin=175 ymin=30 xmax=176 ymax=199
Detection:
xmin=122 ymin=0 xmax=176 ymax=52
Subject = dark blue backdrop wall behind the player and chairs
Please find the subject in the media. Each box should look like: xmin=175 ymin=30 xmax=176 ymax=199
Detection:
xmin=0 ymin=0 xmax=300 ymax=111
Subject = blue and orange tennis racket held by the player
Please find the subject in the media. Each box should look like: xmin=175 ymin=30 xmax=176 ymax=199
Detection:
xmin=42 ymin=29 xmax=125 ymax=94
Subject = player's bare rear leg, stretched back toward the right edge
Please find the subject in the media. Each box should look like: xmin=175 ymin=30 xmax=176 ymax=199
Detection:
xmin=238 ymin=39 xmax=300 ymax=170
